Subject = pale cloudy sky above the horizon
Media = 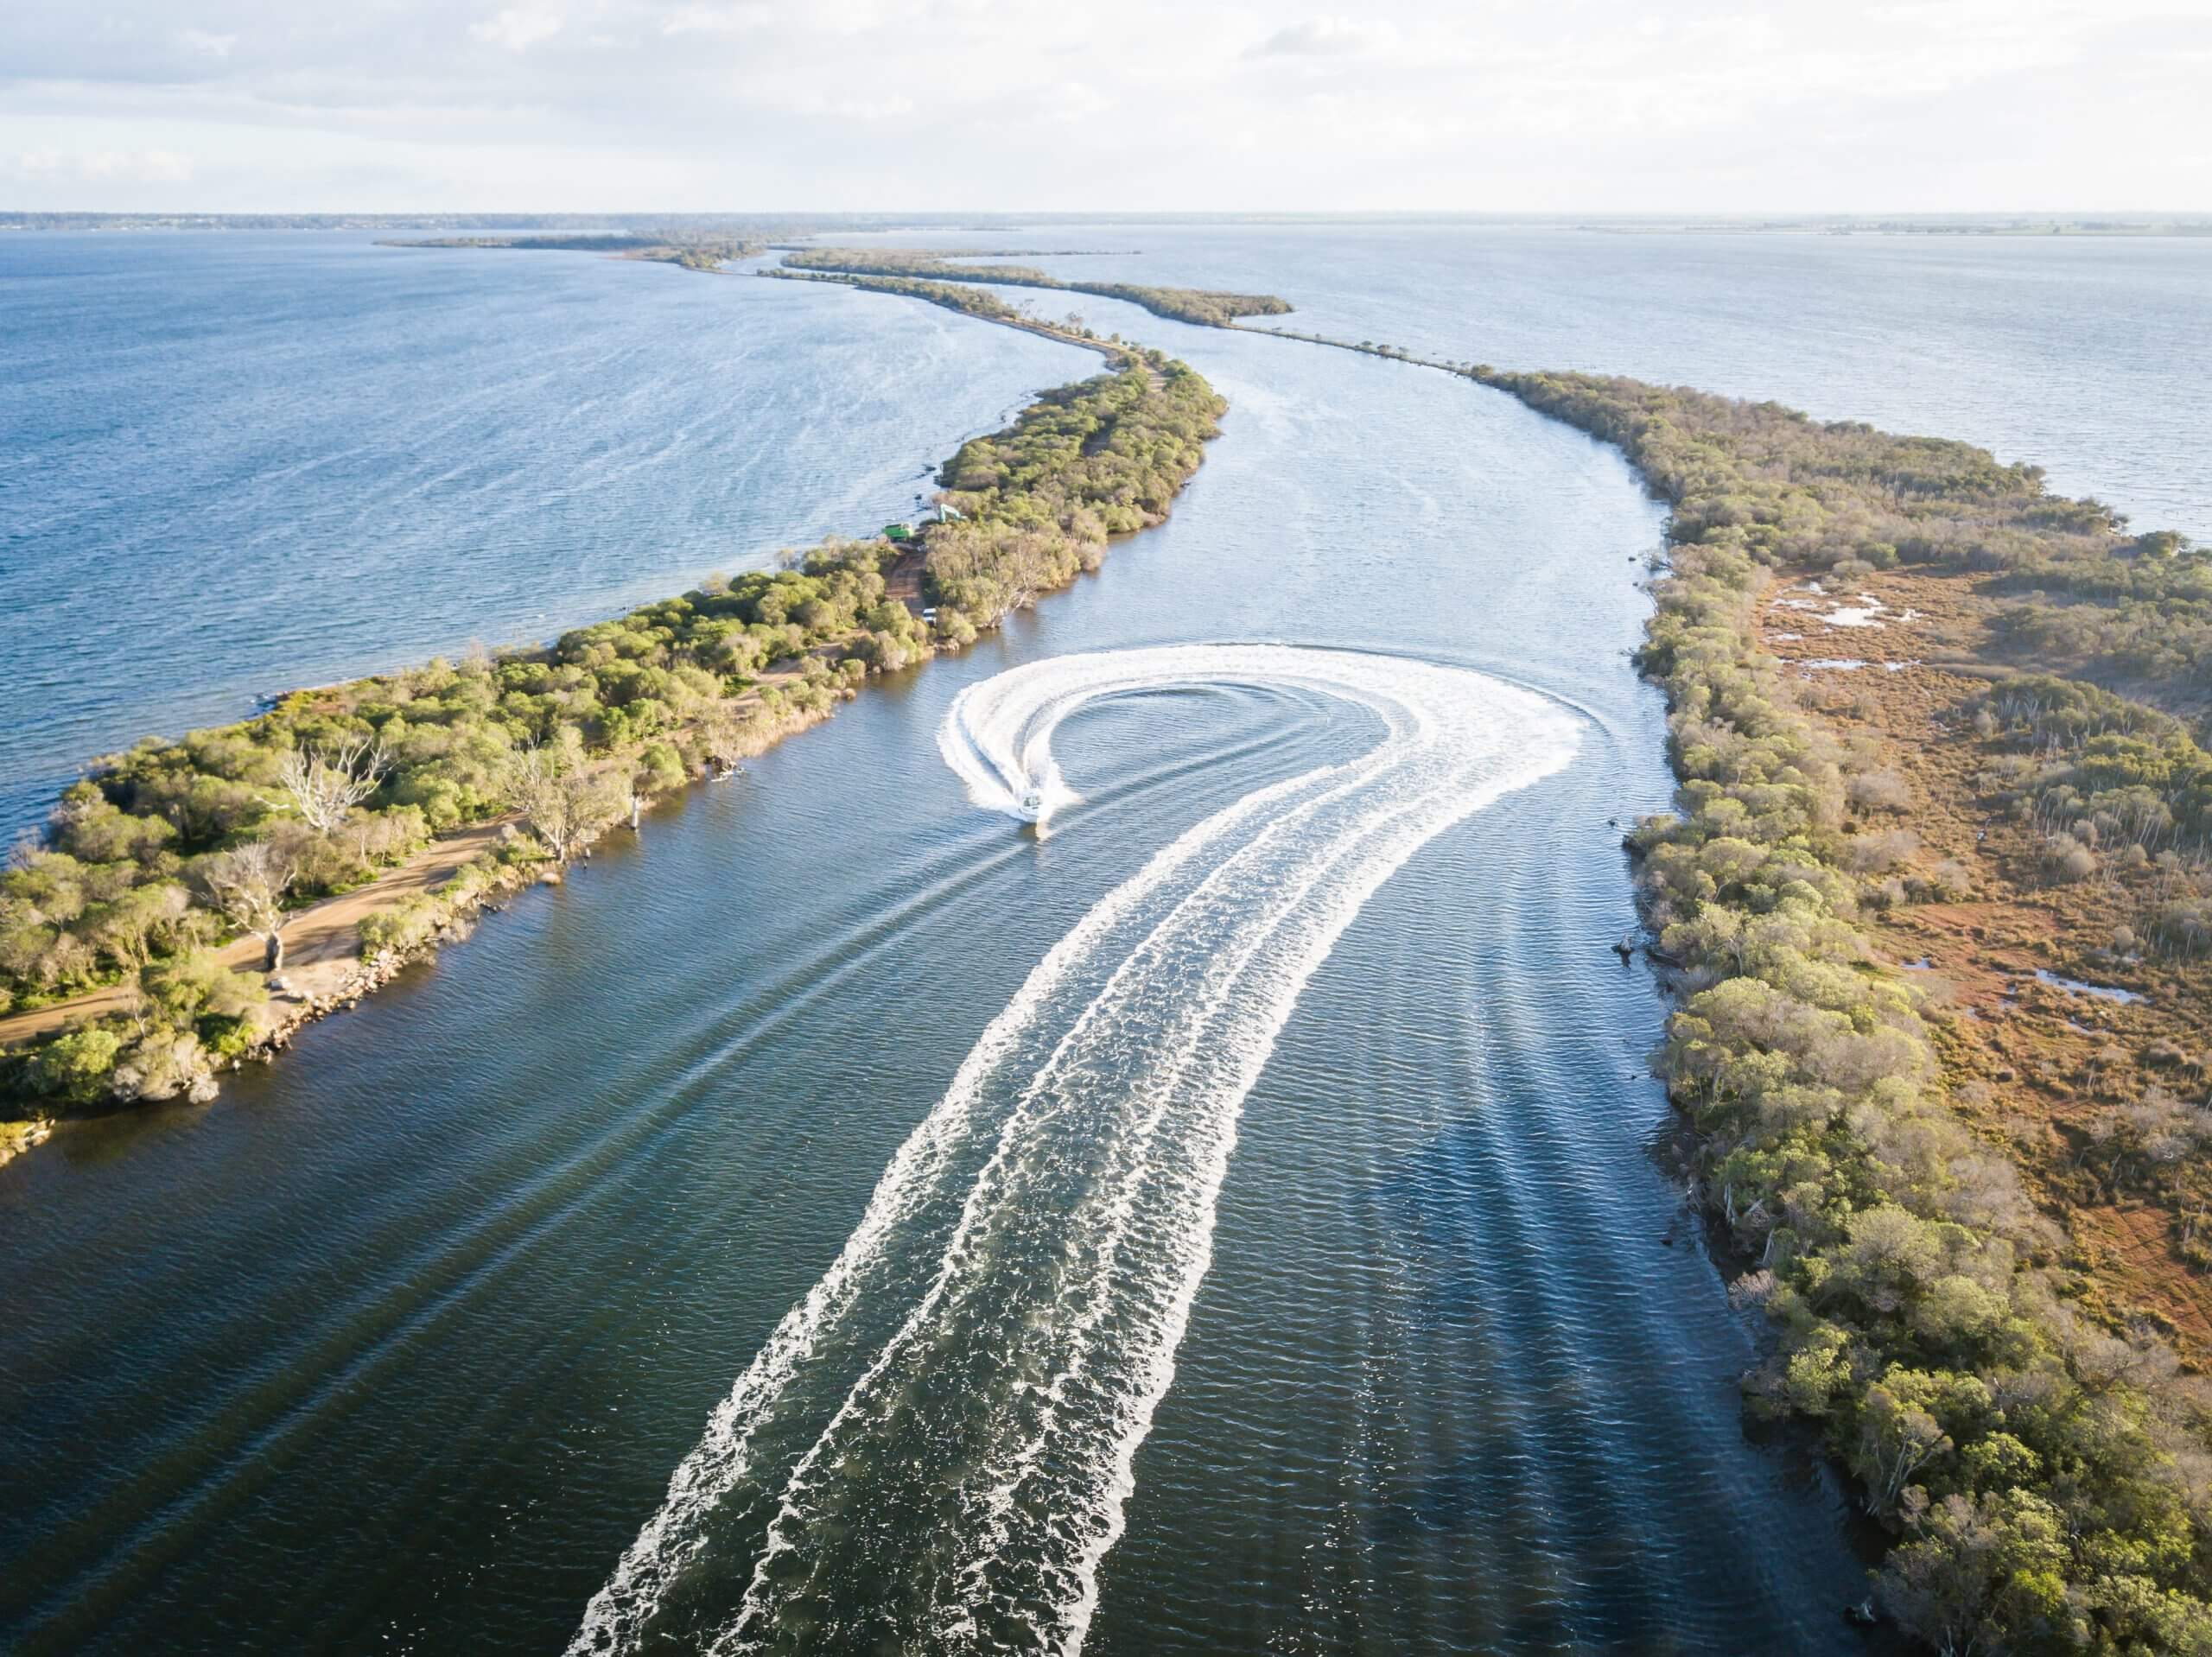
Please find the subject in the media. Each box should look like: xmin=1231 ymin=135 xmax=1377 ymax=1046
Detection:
xmin=0 ymin=0 xmax=2212 ymax=214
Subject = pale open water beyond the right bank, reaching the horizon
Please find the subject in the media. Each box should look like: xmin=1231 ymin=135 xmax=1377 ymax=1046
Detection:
xmin=909 ymin=224 xmax=2212 ymax=540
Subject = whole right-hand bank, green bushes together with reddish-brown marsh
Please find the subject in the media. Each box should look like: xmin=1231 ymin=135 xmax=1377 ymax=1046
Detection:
xmin=1473 ymin=370 xmax=2212 ymax=1654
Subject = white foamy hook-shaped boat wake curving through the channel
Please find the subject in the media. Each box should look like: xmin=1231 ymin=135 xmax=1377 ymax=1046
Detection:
xmin=570 ymin=646 xmax=1577 ymax=1653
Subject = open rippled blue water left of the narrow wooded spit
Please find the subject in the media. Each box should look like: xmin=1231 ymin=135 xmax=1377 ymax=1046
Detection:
xmin=0 ymin=234 xmax=1073 ymax=832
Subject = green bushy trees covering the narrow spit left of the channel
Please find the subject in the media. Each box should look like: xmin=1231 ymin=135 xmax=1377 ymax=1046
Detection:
xmin=0 ymin=350 xmax=1224 ymax=1110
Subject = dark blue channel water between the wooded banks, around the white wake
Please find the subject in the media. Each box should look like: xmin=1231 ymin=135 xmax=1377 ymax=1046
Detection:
xmin=0 ymin=232 xmax=2177 ymax=1657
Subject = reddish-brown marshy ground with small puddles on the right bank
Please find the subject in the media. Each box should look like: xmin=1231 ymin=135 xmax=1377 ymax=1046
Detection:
xmin=1758 ymin=571 xmax=2212 ymax=1369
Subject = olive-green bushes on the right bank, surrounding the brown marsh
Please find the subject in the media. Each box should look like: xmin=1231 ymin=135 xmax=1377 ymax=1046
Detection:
xmin=1476 ymin=370 xmax=2212 ymax=1657
